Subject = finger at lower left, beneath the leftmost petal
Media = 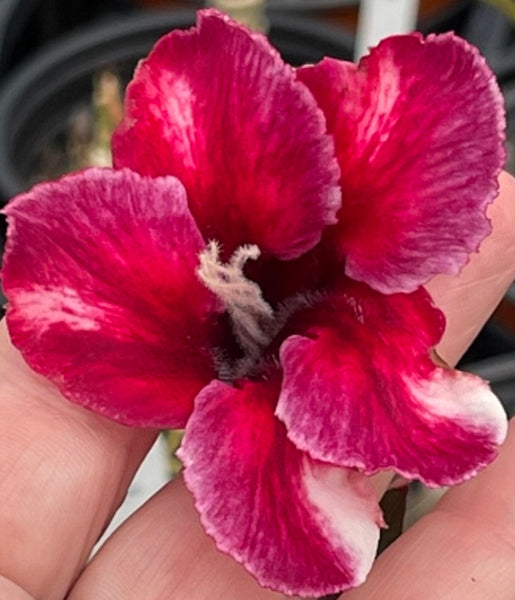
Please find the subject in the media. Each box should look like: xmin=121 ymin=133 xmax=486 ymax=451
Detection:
xmin=0 ymin=323 xmax=155 ymax=599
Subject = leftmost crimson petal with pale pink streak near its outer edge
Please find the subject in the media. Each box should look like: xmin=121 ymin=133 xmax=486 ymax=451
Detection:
xmin=3 ymin=169 xmax=219 ymax=427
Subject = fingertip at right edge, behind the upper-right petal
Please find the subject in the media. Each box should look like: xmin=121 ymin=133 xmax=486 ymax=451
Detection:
xmin=427 ymin=173 xmax=515 ymax=364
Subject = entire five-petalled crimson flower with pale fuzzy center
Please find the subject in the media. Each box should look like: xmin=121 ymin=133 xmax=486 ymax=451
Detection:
xmin=3 ymin=10 xmax=506 ymax=596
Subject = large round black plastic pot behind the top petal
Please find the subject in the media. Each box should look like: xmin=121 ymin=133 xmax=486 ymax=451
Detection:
xmin=0 ymin=11 xmax=352 ymax=202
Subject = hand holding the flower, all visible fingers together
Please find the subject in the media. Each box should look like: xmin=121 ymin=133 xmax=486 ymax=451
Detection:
xmin=0 ymin=170 xmax=515 ymax=600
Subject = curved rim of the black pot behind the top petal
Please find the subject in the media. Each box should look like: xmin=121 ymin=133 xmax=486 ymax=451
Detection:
xmin=0 ymin=10 xmax=352 ymax=200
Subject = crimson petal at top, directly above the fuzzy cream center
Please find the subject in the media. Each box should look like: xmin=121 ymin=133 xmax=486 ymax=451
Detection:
xmin=113 ymin=10 xmax=340 ymax=259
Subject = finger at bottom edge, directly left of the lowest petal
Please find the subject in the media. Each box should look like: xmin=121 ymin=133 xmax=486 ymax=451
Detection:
xmin=69 ymin=478 xmax=304 ymax=600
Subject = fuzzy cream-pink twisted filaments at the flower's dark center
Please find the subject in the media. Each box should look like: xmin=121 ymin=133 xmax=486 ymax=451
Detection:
xmin=197 ymin=241 xmax=275 ymax=358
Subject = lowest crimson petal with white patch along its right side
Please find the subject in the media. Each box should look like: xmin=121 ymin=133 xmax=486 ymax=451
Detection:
xmin=180 ymin=380 xmax=381 ymax=596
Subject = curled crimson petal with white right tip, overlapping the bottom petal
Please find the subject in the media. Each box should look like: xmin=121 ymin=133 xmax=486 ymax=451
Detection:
xmin=276 ymin=283 xmax=507 ymax=485
